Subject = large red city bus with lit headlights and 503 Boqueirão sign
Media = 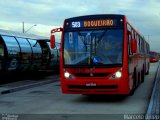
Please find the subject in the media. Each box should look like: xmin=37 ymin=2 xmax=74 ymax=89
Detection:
xmin=51 ymin=14 xmax=150 ymax=95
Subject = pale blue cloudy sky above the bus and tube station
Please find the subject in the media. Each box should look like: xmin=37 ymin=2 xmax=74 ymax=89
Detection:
xmin=0 ymin=0 xmax=160 ymax=52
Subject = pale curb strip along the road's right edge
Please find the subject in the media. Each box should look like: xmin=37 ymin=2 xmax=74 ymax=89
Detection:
xmin=146 ymin=63 xmax=160 ymax=116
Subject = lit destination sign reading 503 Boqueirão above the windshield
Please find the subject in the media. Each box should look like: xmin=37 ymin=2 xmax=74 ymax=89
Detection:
xmin=66 ymin=19 xmax=117 ymax=28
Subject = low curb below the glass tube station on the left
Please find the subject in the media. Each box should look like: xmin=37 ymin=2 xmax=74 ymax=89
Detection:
xmin=0 ymin=76 xmax=59 ymax=95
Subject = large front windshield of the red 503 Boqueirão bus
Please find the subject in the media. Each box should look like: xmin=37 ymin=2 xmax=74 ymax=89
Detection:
xmin=63 ymin=29 xmax=123 ymax=66
